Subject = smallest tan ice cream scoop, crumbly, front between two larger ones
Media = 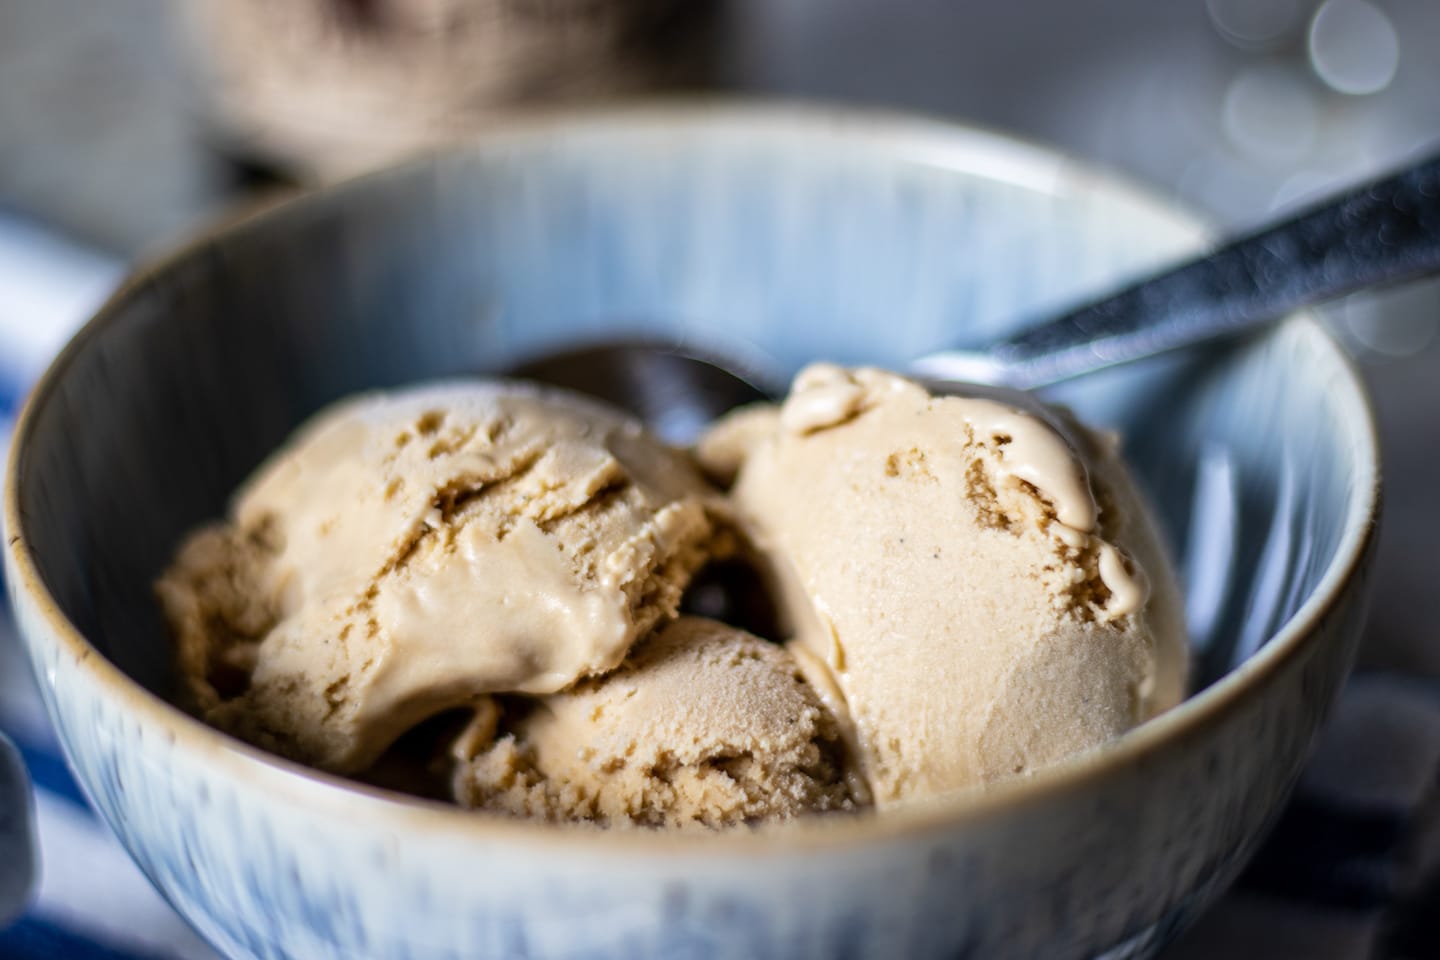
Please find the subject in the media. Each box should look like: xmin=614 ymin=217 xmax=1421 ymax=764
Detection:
xmin=454 ymin=617 xmax=855 ymax=826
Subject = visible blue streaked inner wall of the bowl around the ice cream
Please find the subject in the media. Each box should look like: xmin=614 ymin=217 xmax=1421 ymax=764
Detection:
xmin=12 ymin=109 xmax=1374 ymax=713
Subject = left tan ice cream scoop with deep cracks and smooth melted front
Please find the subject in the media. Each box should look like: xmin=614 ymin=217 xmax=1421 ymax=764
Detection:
xmin=157 ymin=383 xmax=716 ymax=773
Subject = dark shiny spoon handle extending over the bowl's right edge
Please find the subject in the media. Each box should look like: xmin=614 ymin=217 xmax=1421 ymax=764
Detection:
xmin=988 ymin=154 xmax=1440 ymax=387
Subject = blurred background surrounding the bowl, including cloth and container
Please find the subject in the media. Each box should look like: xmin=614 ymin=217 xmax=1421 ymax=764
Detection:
xmin=0 ymin=0 xmax=1440 ymax=957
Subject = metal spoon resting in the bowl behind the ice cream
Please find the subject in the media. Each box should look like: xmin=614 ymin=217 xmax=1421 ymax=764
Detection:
xmin=511 ymin=154 xmax=1440 ymax=442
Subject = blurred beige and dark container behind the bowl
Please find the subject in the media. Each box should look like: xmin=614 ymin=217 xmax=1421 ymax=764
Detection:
xmin=179 ymin=0 xmax=719 ymax=178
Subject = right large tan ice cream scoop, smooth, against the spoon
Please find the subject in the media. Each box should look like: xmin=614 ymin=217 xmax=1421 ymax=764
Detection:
xmin=700 ymin=364 xmax=1185 ymax=806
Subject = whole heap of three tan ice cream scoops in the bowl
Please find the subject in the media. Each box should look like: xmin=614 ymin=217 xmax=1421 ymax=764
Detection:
xmin=157 ymin=364 xmax=1185 ymax=828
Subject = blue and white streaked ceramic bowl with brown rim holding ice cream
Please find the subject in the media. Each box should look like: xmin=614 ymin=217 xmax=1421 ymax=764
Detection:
xmin=4 ymin=107 xmax=1378 ymax=960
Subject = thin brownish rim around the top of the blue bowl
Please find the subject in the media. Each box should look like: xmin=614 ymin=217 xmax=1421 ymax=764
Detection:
xmin=3 ymin=98 xmax=1381 ymax=858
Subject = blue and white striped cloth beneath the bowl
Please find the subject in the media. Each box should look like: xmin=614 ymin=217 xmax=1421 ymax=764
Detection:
xmin=0 ymin=217 xmax=1440 ymax=960
